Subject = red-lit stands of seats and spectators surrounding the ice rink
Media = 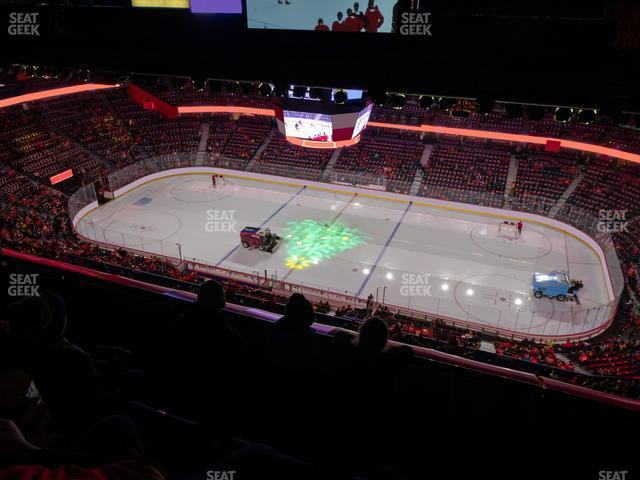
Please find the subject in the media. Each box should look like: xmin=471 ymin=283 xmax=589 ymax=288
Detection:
xmin=6 ymin=83 xmax=640 ymax=408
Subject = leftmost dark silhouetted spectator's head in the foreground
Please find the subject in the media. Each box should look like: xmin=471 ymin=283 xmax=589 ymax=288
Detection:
xmin=7 ymin=292 xmax=67 ymax=342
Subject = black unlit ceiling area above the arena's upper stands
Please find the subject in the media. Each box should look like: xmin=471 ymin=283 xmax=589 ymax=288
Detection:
xmin=0 ymin=0 xmax=640 ymax=111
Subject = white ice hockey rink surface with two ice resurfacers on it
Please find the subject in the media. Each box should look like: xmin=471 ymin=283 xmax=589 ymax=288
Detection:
xmin=78 ymin=174 xmax=610 ymax=339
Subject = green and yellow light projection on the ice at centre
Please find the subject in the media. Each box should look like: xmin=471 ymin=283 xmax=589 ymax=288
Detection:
xmin=284 ymin=219 xmax=365 ymax=270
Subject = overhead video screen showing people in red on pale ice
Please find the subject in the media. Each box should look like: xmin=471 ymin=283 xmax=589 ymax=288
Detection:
xmin=247 ymin=0 xmax=398 ymax=33
